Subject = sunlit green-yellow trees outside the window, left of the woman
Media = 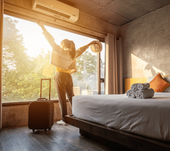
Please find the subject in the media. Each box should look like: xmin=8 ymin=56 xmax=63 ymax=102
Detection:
xmin=2 ymin=17 xmax=57 ymax=102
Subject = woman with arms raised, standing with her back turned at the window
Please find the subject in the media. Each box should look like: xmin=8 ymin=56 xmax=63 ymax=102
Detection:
xmin=37 ymin=20 xmax=97 ymax=125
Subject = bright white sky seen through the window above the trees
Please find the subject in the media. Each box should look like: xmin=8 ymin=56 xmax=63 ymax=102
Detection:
xmin=5 ymin=15 xmax=104 ymax=60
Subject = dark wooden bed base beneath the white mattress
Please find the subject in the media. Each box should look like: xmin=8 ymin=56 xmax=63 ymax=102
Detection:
xmin=65 ymin=115 xmax=170 ymax=151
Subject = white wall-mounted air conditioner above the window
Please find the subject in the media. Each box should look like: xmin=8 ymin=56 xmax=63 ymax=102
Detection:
xmin=32 ymin=0 xmax=79 ymax=23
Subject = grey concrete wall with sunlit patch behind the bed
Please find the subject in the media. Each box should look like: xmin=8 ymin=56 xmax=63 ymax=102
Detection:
xmin=120 ymin=5 xmax=170 ymax=78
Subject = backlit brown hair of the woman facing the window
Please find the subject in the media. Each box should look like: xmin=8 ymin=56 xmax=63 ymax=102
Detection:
xmin=61 ymin=39 xmax=76 ymax=59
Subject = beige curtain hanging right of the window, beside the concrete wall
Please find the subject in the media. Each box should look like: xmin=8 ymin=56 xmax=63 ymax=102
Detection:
xmin=105 ymin=33 xmax=123 ymax=94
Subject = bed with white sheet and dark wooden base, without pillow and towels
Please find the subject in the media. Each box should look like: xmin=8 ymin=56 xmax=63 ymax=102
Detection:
xmin=66 ymin=76 xmax=170 ymax=151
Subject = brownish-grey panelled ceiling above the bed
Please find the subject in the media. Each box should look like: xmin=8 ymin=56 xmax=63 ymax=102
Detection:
xmin=58 ymin=0 xmax=170 ymax=26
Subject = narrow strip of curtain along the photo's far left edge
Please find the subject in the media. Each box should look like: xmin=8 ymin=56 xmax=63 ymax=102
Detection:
xmin=0 ymin=0 xmax=4 ymax=128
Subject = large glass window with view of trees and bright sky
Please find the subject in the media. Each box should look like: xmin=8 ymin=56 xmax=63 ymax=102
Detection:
xmin=2 ymin=15 xmax=105 ymax=102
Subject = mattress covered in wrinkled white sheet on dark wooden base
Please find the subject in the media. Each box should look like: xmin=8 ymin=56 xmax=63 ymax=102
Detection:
xmin=72 ymin=92 xmax=170 ymax=141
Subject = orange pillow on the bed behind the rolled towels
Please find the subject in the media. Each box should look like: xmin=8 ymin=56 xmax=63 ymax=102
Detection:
xmin=149 ymin=73 xmax=170 ymax=92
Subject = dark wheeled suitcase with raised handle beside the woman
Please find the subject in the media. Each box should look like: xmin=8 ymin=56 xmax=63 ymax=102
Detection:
xmin=28 ymin=79 xmax=54 ymax=132
